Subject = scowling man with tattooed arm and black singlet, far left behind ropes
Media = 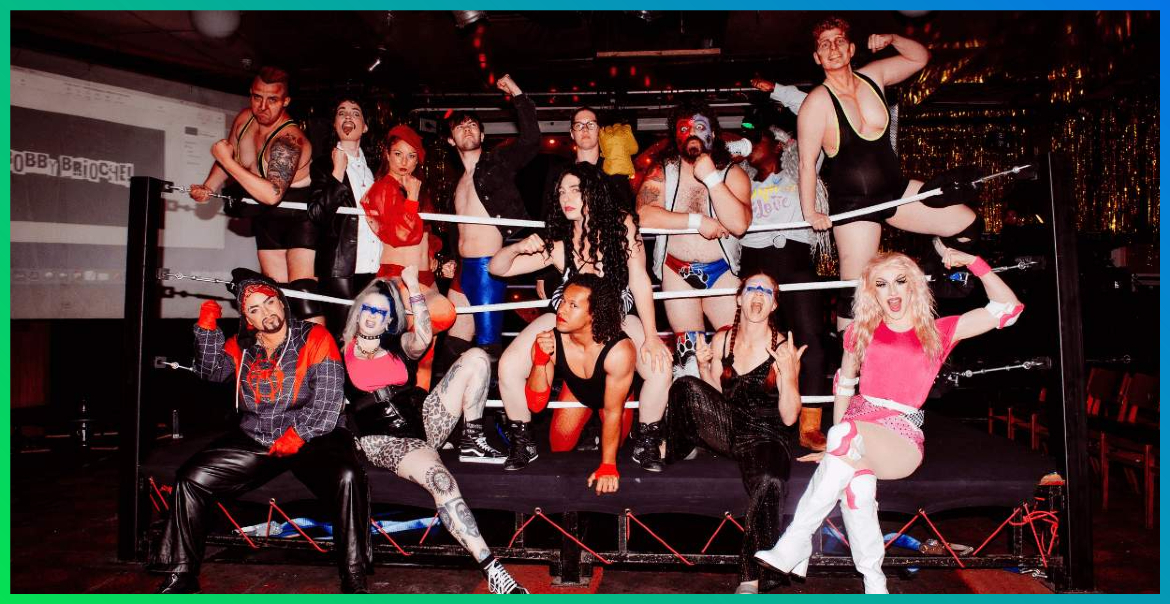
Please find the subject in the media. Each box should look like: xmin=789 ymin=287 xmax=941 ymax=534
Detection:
xmin=190 ymin=67 xmax=324 ymax=323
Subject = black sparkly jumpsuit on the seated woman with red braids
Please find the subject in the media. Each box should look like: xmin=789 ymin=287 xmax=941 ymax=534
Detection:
xmin=666 ymin=338 xmax=797 ymax=591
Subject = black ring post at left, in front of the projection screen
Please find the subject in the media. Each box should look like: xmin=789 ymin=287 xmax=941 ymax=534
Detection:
xmin=118 ymin=177 xmax=165 ymax=561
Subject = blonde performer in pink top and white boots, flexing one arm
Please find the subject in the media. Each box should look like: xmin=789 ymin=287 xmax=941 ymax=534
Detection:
xmin=756 ymin=248 xmax=1024 ymax=593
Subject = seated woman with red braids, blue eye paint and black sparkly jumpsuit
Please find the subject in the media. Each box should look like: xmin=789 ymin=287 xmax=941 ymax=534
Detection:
xmin=666 ymin=273 xmax=807 ymax=593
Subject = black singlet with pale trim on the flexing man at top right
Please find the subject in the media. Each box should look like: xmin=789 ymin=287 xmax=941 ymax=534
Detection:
xmin=821 ymin=74 xmax=906 ymax=201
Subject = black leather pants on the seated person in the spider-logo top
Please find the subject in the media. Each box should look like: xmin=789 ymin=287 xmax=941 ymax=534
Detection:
xmin=151 ymin=428 xmax=372 ymax=577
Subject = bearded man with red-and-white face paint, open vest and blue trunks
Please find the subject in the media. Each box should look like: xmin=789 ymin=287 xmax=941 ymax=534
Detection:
xmin=638 ymin=98 xmax=751 ymax=375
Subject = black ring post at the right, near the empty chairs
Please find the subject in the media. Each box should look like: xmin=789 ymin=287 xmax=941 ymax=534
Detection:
xmin=1041 ymin=153 xmax=1093 ymax=591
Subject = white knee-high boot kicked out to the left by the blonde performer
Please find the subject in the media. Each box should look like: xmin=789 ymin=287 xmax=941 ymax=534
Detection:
xmin=756 ymin=455 xmax=853 ymax=577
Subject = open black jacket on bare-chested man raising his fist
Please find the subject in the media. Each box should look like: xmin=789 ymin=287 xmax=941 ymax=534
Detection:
xmin=472 ymin=95 xmax=541 ymax=238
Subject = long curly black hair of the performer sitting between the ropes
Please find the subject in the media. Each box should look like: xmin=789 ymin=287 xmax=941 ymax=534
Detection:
xmin=544 ymin=162 xmax=638 ymax=283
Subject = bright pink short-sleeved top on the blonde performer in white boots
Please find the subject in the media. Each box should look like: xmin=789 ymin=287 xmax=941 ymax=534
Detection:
xmin=845 ymin=315 xmax=959 ymax=407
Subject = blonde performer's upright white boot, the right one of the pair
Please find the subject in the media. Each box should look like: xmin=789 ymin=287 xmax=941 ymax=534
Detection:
xmin=841 ymin=471 xmax=889 ymax=593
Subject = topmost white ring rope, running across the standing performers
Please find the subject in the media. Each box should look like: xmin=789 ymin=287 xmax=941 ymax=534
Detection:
xmin=167 ymin=164 xmax=1032 ymax=235
